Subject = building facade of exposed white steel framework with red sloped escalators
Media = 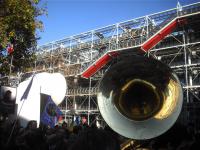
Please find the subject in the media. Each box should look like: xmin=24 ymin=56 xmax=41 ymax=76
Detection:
xmin=1 ymin=2 xmax=200 ymax=124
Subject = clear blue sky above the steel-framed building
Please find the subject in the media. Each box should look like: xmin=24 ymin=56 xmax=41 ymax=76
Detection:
xmin=38 ymin=0 xmax=200 ymax=45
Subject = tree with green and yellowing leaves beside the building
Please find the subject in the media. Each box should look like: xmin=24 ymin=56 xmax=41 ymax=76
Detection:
xmin=0 ymin=0 xmax=46 ymax=75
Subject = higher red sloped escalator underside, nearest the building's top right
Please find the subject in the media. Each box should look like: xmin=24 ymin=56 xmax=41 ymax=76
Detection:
xmin=141 ymin=19 xmax=186 ymax=52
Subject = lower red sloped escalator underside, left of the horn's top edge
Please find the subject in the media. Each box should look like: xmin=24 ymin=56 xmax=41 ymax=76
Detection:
xmin=82 ymin=52 xmax=119 ymax=78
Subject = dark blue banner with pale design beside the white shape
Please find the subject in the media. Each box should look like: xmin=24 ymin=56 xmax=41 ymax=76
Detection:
xmin=40 ymin=93 xmax=62 ymax=128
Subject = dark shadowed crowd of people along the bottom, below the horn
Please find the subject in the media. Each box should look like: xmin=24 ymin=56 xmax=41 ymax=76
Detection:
xmin=0 ymin=116 xmax=200 ymax=150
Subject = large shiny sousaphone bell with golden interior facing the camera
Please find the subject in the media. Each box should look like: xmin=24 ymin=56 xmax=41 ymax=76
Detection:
xmin=97 ymin=56 xmax=183 ymax=140
